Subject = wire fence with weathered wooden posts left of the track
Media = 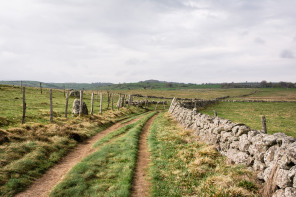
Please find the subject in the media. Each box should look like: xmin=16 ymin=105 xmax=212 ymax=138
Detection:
xmin=0 ymin=87 xmax=169 ymax=127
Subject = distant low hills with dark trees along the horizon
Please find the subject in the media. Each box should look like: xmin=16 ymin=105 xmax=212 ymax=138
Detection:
xmin=0 ymin=79 xmax=296 ymax=90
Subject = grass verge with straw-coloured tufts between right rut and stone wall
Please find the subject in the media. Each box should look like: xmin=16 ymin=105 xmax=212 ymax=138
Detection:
xmin=148 ymin=113 xmax=258 ymax=197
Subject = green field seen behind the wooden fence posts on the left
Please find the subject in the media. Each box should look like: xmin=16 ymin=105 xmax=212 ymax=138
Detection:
xmin=0 ymin=85 xmax=157 ymax=129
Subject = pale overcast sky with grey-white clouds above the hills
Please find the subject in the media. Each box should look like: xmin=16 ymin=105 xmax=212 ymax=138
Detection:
xmin=0 ymin=0 xmax=296 ymax=84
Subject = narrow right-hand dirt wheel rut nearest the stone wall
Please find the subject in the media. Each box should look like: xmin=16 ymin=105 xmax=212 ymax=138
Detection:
xmin=131 ymin=115 xmax=157 ymax=197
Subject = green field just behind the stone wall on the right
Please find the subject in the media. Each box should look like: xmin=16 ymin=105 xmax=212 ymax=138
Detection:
xmin=200 ymin=102 xmax=296 ymax=137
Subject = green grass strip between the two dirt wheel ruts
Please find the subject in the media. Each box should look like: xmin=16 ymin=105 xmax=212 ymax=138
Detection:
xmin=50 ymin=112 xmax=156 ymax=196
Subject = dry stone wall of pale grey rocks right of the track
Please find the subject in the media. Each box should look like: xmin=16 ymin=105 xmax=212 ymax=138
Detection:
xmin=169 ymin=99 xmax=296 ymax=197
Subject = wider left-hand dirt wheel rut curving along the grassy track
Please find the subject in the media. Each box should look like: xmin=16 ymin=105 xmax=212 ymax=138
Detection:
xmin=16 ymin=116 xmax=142 ymax=197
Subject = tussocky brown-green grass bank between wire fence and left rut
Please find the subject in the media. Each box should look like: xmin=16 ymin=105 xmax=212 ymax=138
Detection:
xmin=0 ymin=108 xmax=147 ymax=196
